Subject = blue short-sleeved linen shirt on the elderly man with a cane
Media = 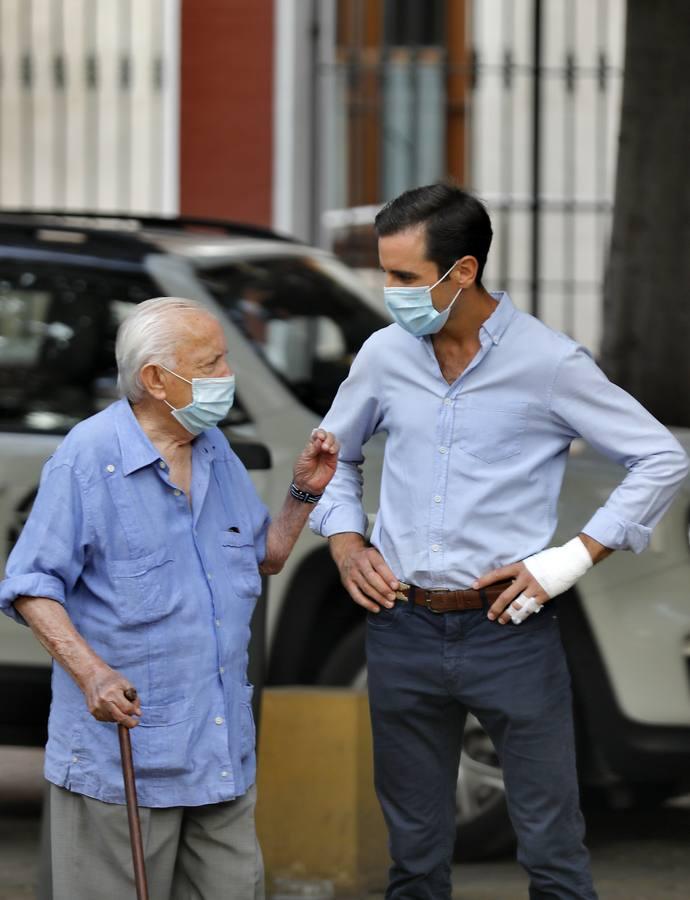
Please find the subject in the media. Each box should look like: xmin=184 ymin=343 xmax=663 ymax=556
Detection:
xmin=0 ymin=400 xmax=269 ymax=807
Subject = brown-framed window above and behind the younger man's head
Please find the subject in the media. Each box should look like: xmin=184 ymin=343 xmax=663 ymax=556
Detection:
xmin=330 ymin=0 xmax=464 ymax=216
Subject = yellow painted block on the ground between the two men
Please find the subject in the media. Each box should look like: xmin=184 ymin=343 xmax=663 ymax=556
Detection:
xmin=257 ymin=687 xmax=390 ymax=896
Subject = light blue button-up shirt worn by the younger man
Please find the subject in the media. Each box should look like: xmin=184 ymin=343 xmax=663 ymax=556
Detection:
xmin=311 ymin=293 xmax=688 ymax=589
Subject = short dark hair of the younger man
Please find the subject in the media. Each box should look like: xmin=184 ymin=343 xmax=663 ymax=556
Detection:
xmin=374 ymin=182 xmax=493 ymax=286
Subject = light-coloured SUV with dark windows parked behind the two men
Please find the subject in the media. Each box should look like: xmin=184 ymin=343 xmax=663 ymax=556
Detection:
xmin=0 ymin=213 xmax=690 ymax=858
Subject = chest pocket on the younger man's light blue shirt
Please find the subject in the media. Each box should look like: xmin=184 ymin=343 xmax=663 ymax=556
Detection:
xmin=457 ymin=400 xmax=528 ymax=463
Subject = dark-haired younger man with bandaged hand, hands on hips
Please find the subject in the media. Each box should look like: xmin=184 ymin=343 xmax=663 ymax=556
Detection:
xmin=312 ymin=184 xmax=687 ymax=900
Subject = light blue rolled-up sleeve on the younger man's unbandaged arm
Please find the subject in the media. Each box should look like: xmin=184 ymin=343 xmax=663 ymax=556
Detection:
xmin=309 ymin=344 xmax=381 ymax=537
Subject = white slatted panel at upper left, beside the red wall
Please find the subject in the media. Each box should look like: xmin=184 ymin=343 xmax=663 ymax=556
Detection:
xmin=0 ymin=0 xmax=180 ymax=213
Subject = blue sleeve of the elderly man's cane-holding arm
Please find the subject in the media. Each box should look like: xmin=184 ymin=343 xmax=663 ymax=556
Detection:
xmin=0 ymin=460 xmax=88 ymax=624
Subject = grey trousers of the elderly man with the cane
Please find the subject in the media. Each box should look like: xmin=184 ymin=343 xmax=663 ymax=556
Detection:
xmin=43 ymin=785 xmax=264 ymax=900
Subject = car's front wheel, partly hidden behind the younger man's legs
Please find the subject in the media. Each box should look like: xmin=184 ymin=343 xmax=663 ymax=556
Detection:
xmin=318 ymin=623 xmax=515 ymax=861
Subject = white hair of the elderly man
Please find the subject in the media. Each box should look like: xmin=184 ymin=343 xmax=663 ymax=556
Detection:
xmin=115 ymin=297 xmax=213 ymax=403
